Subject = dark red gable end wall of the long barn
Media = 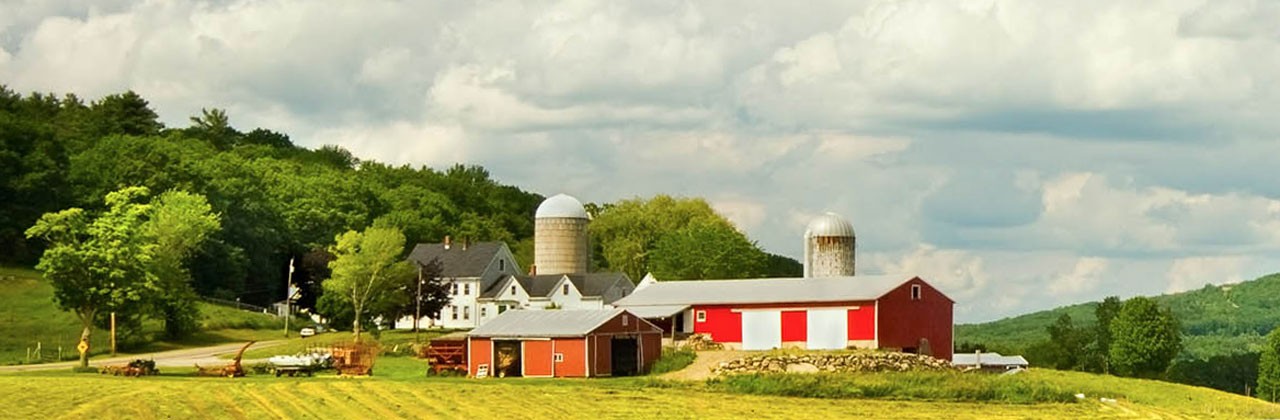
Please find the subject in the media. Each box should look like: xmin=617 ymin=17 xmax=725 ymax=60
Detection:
xmin=879 ymin=278 xmax=955 ymax=360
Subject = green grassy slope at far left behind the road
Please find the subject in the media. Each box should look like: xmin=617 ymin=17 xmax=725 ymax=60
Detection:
xmin=0 ymin=268 xmax=294 ymax=365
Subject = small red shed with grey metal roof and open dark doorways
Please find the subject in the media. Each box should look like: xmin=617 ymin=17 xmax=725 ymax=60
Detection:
xmin=467 ymin=309 xmax=662 ymax=378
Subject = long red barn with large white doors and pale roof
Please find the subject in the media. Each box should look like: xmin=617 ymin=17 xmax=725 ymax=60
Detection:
xmin=614 ymin=275 xmax=955 ymax=360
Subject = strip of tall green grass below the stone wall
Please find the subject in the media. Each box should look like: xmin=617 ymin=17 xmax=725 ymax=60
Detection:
xmin=708 ymin=371 xmax=1075 ymax=403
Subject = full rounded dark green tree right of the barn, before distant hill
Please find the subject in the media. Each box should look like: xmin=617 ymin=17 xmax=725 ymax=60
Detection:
xmin=1108 ymin=297 xmax=1181 ymax=378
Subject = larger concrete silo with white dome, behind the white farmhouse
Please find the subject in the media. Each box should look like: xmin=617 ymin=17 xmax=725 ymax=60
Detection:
xmin=530 ymin=193 xmax=591 ymax=274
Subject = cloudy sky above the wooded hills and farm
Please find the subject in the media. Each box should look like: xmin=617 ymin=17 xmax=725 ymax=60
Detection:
xmin=0 ymin=0 xmax=1280 ymax=321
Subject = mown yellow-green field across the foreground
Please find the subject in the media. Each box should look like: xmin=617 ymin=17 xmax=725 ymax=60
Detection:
xmin=0 ymin=357 xmax=1280 ymax=419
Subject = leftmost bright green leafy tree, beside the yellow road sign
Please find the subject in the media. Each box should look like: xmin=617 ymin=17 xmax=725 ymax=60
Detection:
xmin=27 ymin=187 xmax=157 ymax=368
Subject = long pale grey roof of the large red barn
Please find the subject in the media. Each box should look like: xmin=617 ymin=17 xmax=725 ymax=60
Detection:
xmin=613 ymin=275 xmax=936 ymax=307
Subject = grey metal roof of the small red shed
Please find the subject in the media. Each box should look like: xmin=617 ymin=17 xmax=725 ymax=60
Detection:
xmin=467 ymin=309 xmax=626 ymax=338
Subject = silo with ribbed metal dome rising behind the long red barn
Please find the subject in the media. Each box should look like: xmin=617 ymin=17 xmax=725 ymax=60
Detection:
xmin=804 ymin=213 xmax=858 ymax=277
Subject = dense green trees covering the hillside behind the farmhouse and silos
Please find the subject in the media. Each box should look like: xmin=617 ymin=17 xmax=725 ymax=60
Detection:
xmin=0 ymin=86 xmax=800 ymax=350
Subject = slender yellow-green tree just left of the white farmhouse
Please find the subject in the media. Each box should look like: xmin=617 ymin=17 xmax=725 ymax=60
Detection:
xmin=323 ymin=227 xmax=416 ymax=342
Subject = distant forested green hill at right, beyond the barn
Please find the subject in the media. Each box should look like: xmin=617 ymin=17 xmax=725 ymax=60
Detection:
xmin=955 ymin=270 xmax=1280 ymax=359
